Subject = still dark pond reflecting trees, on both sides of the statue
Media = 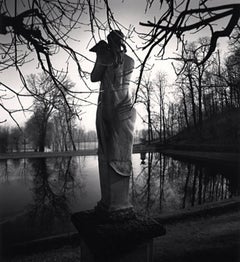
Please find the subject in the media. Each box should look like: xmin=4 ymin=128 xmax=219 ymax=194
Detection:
xmin=0 ymin=153 xmax=240 ymax=245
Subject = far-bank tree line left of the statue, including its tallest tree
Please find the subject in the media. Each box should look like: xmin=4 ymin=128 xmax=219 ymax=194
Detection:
xmin=0 ymin=73 xmax=96 ymax=152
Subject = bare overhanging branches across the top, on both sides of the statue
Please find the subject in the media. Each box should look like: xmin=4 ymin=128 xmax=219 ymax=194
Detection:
xmin=0 ymin=0 xmax=240 ymax=124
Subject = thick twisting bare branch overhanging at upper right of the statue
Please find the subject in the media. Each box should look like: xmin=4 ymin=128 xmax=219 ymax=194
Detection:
xmin=135 ymin=0 xmax=240 ymax=102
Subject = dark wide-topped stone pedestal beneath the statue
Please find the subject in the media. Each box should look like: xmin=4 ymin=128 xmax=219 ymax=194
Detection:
xmin=72 ymin=210 xmax=165 ymax=262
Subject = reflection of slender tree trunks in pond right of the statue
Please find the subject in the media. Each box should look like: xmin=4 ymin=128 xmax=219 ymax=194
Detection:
xmin=131 ymin=153 xmax=240 ymax=214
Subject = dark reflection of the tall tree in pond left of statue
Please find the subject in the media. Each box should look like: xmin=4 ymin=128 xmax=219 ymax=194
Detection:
xmin=0 ymin=158 xmax=88 ymax=245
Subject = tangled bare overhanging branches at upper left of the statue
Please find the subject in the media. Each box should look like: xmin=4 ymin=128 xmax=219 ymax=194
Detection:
xmin=0 ymin=0 xmax=117 ymax=123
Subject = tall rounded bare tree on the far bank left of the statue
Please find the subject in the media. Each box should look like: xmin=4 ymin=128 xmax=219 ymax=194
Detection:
xmin=26 ymin=74 xmax=75 ymax=152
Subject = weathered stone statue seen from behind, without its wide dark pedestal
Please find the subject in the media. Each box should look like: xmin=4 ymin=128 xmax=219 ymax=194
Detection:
xmin=90 ymin=30 xmax=136 ymax=212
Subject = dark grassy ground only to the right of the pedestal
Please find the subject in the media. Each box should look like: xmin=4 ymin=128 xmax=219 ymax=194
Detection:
xmin=154 ymin=211 xmax=240 ymax=262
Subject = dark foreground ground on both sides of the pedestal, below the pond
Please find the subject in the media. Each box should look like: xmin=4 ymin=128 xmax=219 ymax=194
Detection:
xmin=1 ymin=198 xmax=240 ymax=262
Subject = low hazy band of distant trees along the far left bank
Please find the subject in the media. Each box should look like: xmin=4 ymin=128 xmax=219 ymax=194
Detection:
xmin=0 ymin=123 xmax=97 ymax=153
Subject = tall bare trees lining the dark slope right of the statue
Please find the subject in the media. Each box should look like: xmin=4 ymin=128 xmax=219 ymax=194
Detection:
xmin=139 ymin=30 xmax=240 ymax=145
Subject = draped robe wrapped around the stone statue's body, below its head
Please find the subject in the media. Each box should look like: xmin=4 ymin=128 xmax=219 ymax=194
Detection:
xmin=96 ymin=54 xmax=136 ymax=176
